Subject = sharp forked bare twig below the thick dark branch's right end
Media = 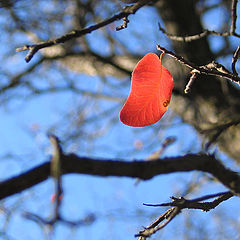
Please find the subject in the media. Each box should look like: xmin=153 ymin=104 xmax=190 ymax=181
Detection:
xmin=135 ymin=191 xmax=234 ymax=240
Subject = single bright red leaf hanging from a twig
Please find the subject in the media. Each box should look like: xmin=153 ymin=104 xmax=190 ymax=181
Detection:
xmin=120 ymin=53 xmax=174 ymax=127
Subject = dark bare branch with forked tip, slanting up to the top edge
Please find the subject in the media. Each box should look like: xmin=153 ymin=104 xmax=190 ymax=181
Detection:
xmin=16 ymin=0 xmax=155 ymax=62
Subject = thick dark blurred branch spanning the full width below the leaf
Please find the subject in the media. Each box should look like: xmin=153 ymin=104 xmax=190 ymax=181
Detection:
xmin=0 ymin=154 xmax=240 ymax=199
